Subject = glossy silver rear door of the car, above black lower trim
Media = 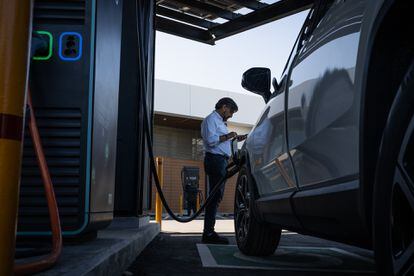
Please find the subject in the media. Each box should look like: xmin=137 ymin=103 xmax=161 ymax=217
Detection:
xmin=287 ymin=1 xmax=366 ymax=187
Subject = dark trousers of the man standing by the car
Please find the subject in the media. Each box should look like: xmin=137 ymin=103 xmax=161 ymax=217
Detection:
xmin=204 ymin=153 xmax=227 ymax=234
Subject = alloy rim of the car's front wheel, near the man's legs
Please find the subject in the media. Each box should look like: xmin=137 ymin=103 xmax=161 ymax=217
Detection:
xmin=235 ymin=175 xmax=250 ymax=242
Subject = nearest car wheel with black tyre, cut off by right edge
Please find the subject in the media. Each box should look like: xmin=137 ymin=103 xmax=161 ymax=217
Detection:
xmin=373 ymin=59 xmax=414 ymax=275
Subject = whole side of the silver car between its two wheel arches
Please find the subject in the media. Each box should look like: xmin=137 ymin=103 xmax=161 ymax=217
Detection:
xmin=243 ymin=0 xmax=393 ymax=247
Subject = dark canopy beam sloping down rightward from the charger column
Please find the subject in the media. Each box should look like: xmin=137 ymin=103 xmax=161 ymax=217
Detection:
xmin=155 ymin=16 xmax=214 ymax=45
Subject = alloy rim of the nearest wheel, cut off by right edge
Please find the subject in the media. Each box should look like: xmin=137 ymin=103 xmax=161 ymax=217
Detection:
xmin=390 ymin=117 xmax=414 ymax=275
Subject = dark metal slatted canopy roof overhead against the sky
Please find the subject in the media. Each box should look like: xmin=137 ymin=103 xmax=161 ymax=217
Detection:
xmin=155 ymin=0 xmax=315 ymax=45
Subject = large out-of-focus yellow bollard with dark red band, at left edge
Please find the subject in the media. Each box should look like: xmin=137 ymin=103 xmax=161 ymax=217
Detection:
xmin=0 ymin=0 xmax=31 ymax=275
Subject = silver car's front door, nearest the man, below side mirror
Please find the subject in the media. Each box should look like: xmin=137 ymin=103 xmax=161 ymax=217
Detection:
xmin=245 ymin=20 xmax=302 ymax=229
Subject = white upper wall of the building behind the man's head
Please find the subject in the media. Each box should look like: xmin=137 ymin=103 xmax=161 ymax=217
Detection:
xmin=154 ymin=79 xmax=264 ymax=126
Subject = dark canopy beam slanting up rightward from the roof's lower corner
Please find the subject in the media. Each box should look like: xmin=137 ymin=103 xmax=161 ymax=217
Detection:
xmin=210 ymin=0 xmax=315 ymax=41
